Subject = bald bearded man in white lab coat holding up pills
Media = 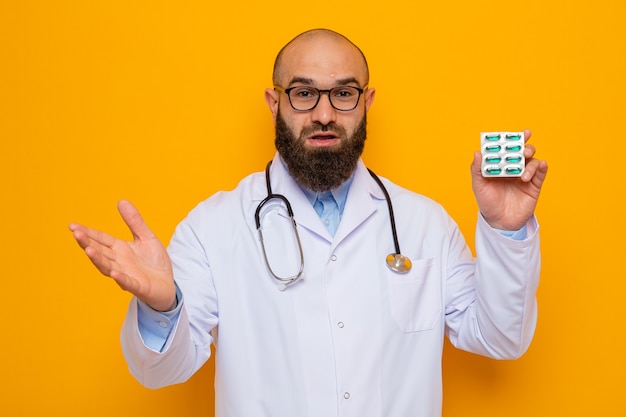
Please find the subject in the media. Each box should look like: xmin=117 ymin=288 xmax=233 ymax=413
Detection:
xmin=70 ymin=30 xmax=547 ymax=417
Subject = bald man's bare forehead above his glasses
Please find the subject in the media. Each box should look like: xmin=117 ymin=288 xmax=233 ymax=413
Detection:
xmin=278 ymin=36 xmax=367 ymax=87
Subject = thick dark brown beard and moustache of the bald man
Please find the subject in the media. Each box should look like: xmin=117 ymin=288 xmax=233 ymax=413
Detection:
xmin=275 ymin=112 xmax=367 ymax=192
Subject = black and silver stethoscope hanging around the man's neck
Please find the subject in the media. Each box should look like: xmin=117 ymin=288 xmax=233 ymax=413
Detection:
xmin=254 ymin=161 xmax=411 ymax=291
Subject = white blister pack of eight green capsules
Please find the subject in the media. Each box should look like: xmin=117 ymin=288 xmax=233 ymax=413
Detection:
xmin=480 ymin=132 xmax=526 ymax=177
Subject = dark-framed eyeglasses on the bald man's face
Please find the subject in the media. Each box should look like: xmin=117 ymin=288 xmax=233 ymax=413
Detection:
xmin=274 ymin=85 xmax=367 ymax=111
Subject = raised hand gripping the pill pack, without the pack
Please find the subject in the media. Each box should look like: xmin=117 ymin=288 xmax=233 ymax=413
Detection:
xmin=471 ymin=130 xmax=548 ymax=230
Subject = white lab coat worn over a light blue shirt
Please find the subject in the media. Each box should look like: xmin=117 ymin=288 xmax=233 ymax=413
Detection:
xmin=122 ymin=153 xmax=540 ymax=417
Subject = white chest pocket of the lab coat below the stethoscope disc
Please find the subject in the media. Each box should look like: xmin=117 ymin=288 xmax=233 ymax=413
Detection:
xmin=387 ymin=258 xmax=442 ymax=333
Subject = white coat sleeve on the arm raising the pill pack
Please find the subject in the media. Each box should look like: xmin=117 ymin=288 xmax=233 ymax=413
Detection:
xmin=446 ymin=213 xmax=541 ymax=359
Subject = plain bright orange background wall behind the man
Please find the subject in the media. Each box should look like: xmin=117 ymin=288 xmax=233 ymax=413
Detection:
xmin=0 ymin=0 xmax=626 ymax=417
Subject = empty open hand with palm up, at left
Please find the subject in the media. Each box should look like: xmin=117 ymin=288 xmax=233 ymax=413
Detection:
xmin=69 ymin=200 xmax=176 ymax=311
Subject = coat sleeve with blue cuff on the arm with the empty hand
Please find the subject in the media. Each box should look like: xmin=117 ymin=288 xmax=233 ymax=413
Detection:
xmin=121 ymin=211 xmax=218 ymax=388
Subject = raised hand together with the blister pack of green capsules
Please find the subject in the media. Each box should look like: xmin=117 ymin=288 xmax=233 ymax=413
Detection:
xmin=472 ymin=130 xmax=548 ymax=230
